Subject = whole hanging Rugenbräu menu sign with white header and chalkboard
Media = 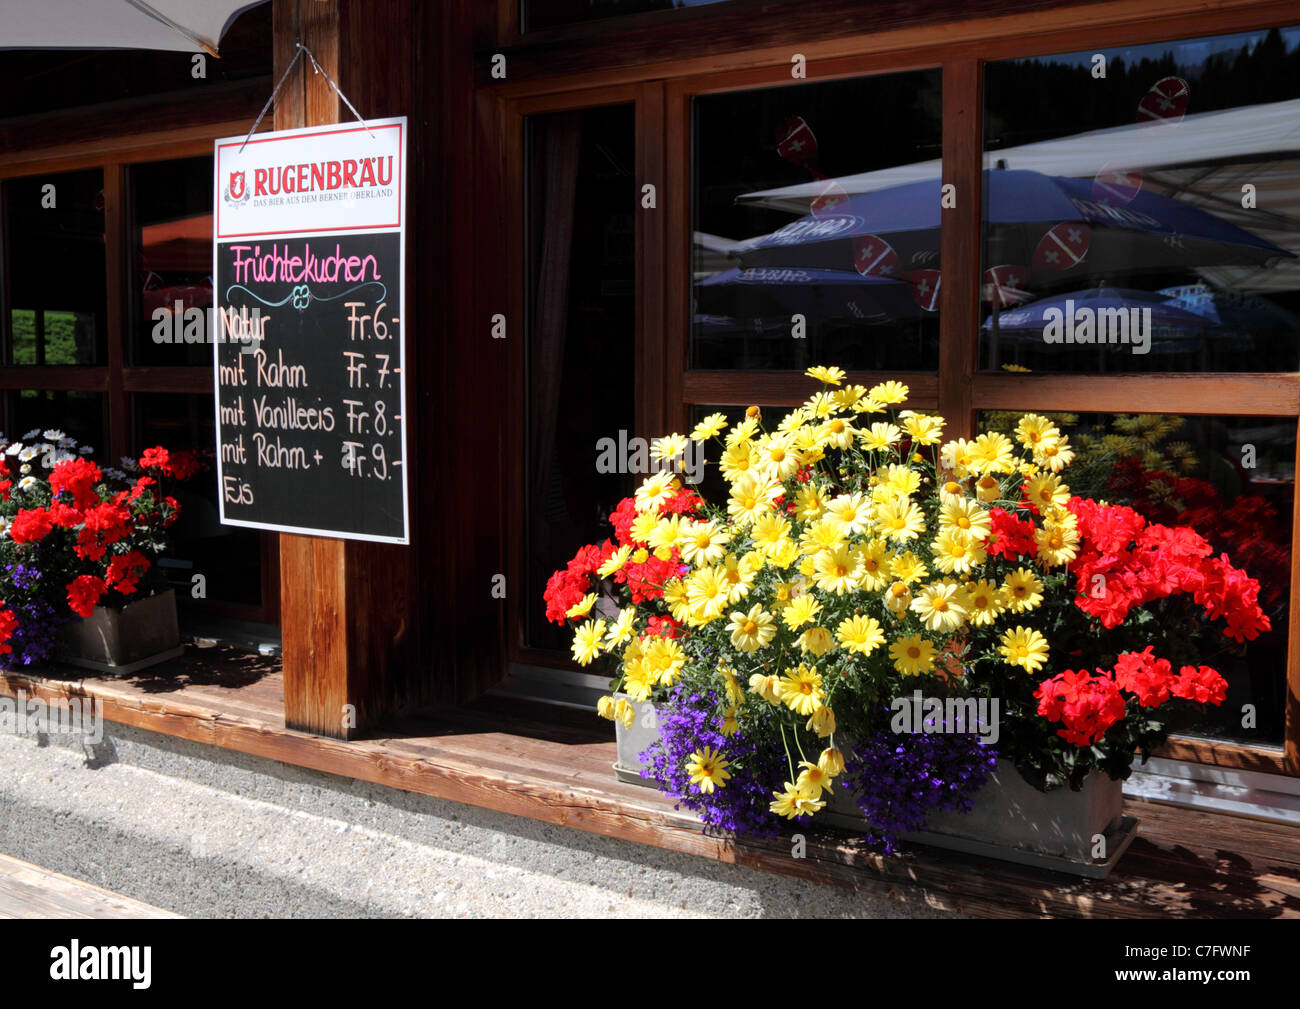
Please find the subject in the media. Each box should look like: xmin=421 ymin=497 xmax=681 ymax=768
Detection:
xmin=212 ymin=117 xmax=408 ymax=544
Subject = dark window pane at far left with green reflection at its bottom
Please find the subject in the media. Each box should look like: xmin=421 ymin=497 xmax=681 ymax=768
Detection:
xmin=0 ymin=169 xmax=107 ymax=365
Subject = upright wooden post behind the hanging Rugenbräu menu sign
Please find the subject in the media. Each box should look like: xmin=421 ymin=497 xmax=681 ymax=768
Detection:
xmin=272 ymin=0 xmax=415 ymax=739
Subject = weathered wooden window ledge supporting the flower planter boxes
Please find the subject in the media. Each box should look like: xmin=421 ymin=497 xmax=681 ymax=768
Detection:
xmin=0 ymin=646 xmax=1300 ymax=918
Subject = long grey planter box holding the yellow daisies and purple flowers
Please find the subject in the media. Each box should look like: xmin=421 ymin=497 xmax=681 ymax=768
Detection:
xmin=614 ymin=694 xmax=1138 ymax=879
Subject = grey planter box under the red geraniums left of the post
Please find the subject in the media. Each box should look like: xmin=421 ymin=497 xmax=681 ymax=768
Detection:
xmin=57 ymin=589 xmax=185 ymax=674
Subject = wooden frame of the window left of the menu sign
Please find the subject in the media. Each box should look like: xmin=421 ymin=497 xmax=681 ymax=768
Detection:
xmin=0 ymin=118 xmax=280 ymax=624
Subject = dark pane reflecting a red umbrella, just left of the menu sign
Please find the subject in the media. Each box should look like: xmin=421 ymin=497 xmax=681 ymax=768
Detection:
xmin=129 ymin=156 xmax=212 ymax=368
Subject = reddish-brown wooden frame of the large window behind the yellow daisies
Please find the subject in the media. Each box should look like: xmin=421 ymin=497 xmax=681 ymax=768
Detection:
xmin=491 ymin=0 xmax=1300 ymax=776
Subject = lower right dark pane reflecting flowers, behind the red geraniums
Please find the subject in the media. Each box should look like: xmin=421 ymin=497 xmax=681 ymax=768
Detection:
xmin=980 ymin=412 xmax=1296 ymax=745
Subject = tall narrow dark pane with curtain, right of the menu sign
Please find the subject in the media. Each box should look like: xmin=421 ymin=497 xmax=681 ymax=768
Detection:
xmin=524 ymin=105 xmax=634 ymax=653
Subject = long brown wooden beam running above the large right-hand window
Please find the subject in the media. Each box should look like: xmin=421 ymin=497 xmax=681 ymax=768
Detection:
xmin=475 ymin=0 xmax=1295 ymax=95
